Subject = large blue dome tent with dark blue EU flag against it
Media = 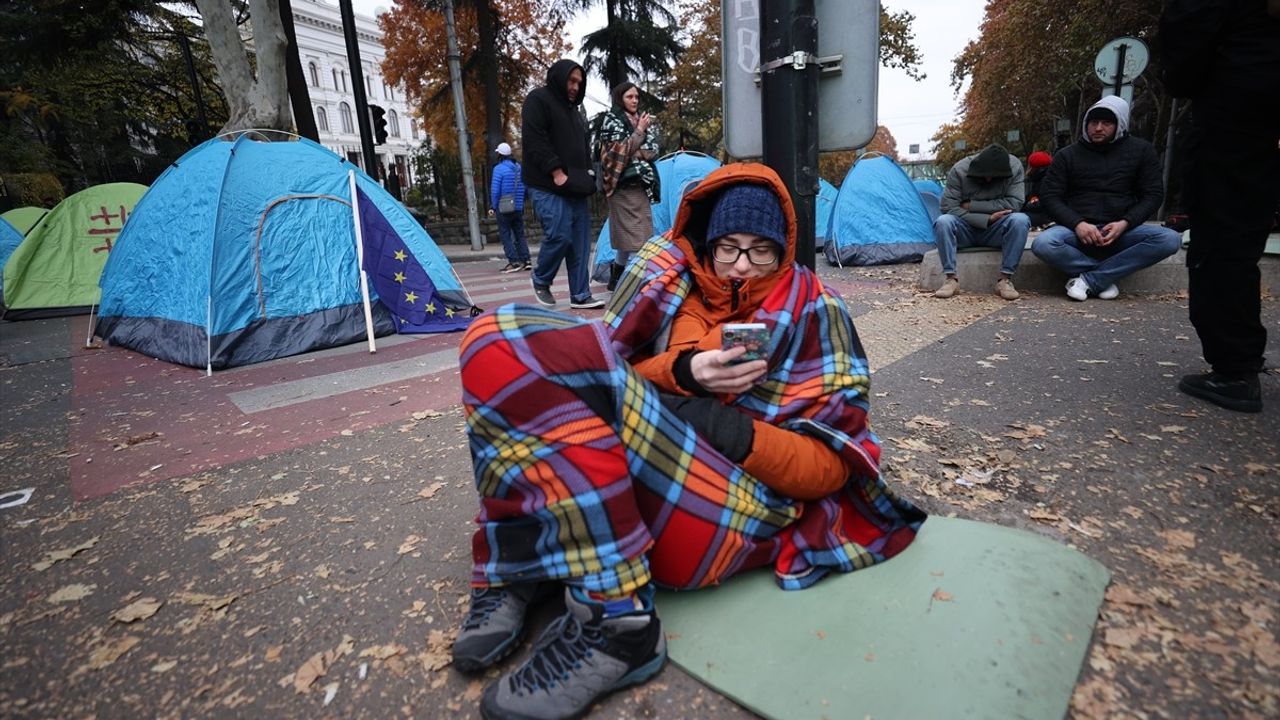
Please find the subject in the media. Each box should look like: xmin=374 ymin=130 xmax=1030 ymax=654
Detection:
xmin=96 ymin=133 xmax=474 ymax=370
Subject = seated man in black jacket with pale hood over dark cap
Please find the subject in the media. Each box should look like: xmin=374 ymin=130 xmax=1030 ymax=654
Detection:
xmin=1032 ymin=95 xmax=1181 ymax=302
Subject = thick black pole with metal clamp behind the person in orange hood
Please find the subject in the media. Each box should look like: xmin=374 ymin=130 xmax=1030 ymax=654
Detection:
xmin=760 ymin=0 xmax=820 ymax=269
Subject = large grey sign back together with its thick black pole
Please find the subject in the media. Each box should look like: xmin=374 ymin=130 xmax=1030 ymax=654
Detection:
xmin=721 ymin=0 xmax=879 ymax=269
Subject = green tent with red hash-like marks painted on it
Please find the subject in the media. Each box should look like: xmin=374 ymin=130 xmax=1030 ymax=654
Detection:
xmin=4 ymin=182 xmax=147 ymax=320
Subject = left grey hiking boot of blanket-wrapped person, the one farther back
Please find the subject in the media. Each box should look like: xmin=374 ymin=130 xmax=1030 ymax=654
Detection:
xmin=453 ymin=583 xmax=552 ymax=673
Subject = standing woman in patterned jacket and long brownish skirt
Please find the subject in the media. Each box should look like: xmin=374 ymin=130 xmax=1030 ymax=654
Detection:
xmin=598 ymin=81 xmax=662 ymax=292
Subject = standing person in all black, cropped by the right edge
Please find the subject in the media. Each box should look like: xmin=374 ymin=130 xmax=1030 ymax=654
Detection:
xmin=1160 ymin=0 xmax=1280 ymax=413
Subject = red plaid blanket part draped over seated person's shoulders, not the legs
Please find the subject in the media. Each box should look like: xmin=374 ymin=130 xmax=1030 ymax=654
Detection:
xmin=604 ymin=242 xmax=925 ymax=589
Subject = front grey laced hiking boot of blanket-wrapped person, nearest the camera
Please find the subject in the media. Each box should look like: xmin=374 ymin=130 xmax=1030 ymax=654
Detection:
xmin=480 ymin=588 xmax=667 ymax=720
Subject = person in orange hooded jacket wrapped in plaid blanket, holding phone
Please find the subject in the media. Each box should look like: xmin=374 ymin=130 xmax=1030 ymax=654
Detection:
xmin=453 ymin=164 xmax=925 ymax=719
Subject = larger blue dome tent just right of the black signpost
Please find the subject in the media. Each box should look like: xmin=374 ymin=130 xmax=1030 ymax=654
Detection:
xmin=822 ymin=155 xmax=933 ymax=265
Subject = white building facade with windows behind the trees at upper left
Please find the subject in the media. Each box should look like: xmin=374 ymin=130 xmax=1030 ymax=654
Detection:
xmin=292 ymin=0 xmax=424 ymax=188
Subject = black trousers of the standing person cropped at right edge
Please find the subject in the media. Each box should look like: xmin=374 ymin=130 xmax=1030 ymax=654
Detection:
xmin=1185 ymin=117 xmax=1280 ymax=375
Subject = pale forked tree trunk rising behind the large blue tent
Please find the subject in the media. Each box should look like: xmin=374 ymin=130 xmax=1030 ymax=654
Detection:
xmin=196 ymin=0 xmax=293 ymax=132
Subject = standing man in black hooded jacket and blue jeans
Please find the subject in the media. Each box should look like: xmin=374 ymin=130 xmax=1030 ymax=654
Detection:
xmin=520 ymin=59 xmax=604 ymax=309
